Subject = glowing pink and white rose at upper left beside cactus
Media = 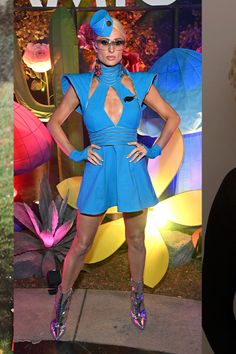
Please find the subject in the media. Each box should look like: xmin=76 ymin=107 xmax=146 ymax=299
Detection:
xmin=22 ymin=43 xmax=51 ymax=73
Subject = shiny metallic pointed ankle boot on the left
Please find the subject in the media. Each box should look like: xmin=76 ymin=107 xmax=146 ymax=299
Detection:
xmin=50 ymin=285 xmax=73 ymax=340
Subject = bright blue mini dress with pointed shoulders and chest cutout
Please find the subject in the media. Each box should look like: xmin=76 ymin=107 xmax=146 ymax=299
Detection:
xmin=61 ymin=68 xmax=159 ymax=214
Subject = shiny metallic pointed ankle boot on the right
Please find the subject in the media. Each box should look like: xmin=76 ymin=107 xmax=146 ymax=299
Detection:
xmin=130 ymin=278 xmax=147 ymax=329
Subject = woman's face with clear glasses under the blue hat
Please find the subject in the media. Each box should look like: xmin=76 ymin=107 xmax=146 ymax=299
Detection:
xmin=94 ymin=28 xmax=125 ymax=66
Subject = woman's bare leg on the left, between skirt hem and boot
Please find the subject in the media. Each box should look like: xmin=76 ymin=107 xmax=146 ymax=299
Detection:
xmin=61 ymin=211 xmax=105 ymax=293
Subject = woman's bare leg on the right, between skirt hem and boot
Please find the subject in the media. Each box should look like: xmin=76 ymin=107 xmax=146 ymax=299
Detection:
xmin=123 ymin=208 xmax=148 ymax=281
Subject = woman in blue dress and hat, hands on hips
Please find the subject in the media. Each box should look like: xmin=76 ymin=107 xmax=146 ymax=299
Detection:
xmin=48 ymin=10 xmax=180 ymax=339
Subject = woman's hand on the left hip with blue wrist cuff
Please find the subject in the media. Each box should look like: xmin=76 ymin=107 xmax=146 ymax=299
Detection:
xmin=69 ymin=144 xmax=103 ymax=165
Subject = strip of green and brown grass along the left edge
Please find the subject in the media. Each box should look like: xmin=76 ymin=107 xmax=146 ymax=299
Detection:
xmin=0 ymin=83 xmax=13 ymax=353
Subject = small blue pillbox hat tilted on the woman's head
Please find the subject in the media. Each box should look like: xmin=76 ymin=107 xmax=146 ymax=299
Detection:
xmin=90 ymin=10 xmax=113 ymax=36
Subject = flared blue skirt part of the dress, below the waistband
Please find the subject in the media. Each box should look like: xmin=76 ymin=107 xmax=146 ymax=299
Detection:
xmin=76 ymin=144 xmax=159 ymax=214
